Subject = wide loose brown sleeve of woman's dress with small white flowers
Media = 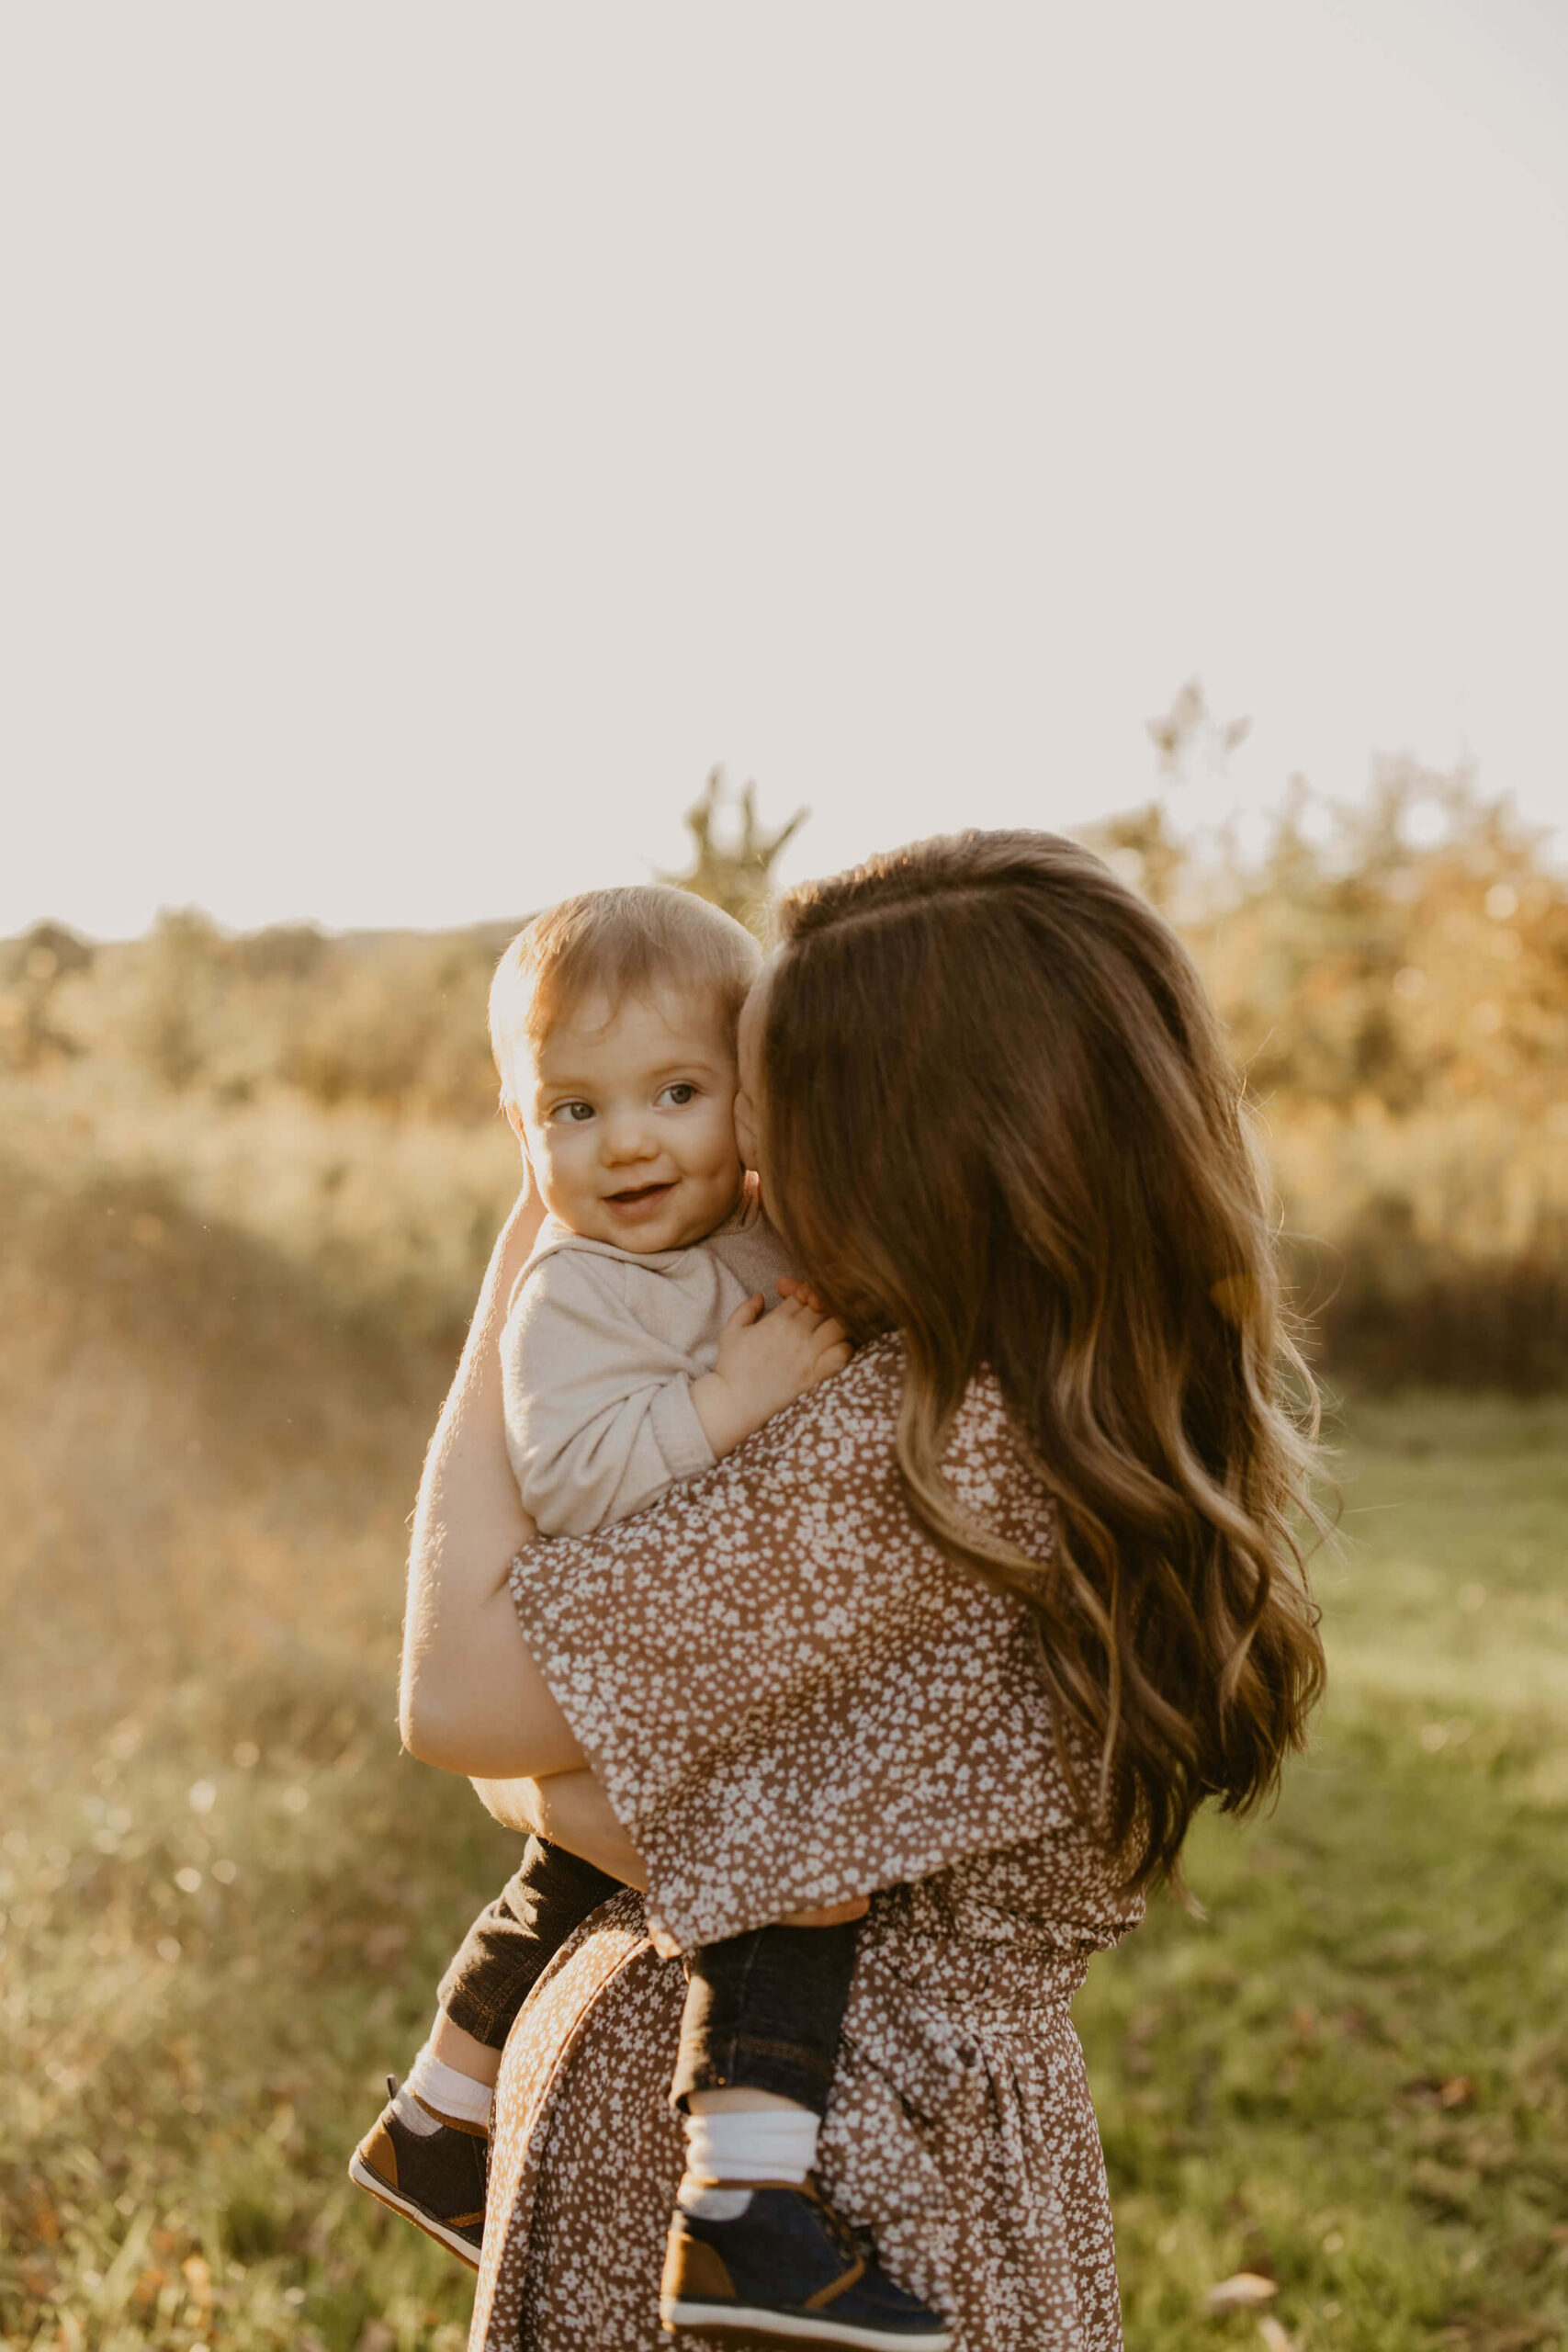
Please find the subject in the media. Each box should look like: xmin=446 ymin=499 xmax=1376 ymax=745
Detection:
xmin=513 ymin=1340 xmax=1069 ymax=1952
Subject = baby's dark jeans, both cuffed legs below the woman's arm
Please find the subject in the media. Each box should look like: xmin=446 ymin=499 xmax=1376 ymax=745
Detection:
xmin=440 ymin=1837 xmax=858 ymax=2114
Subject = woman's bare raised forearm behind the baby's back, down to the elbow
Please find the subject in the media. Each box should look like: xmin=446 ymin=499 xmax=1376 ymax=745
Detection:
xmin=400 ymin=1194 xmax=583 ymax=1781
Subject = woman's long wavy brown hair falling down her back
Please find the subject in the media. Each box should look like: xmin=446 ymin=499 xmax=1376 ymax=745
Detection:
xmin=760 ymin=832 xmax=1324 ymax=1886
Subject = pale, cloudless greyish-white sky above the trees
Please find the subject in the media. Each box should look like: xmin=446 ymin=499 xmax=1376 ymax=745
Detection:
xmin=0 ymin=0 xmax=1568 ymax=936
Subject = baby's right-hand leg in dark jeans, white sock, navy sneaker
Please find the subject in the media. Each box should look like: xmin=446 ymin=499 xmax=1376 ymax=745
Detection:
xmin=659 ymin=1919 xmax=952 ymax=2352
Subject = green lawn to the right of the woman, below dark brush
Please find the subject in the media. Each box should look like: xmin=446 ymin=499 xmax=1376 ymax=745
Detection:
xmin=1079 ymin=1395 xmax=1568 ymax=2352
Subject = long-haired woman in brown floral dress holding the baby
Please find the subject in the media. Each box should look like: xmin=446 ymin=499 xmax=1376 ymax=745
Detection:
xmin=404 ymin=832 xmax=1321 ymax=2352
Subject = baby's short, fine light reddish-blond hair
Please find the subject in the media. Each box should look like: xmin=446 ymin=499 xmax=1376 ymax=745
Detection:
xmin=489 ymin=882 xmax=761 ymax=1101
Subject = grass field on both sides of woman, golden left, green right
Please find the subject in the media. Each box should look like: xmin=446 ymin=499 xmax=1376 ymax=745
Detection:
xmin=0 ymin=1161 xmax=1568 ymax=2352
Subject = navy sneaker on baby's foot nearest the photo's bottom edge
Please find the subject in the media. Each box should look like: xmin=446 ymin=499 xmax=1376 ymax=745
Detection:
xmin=659 ymin=2180 xmax=952 ymax=2352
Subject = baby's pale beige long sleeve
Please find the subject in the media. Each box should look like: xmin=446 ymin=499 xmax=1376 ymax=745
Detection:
xmin=501 ymin=1249 xmax=715 ymax=1536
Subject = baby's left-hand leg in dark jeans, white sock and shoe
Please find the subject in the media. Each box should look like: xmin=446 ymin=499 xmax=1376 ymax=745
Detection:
xmin=348 ymin=1837 xmax=621 ymax=2263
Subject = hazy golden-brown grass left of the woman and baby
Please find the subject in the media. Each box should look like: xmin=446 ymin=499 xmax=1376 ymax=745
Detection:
xmin=0 ymin=1167 xmax=510 ymax=2352
